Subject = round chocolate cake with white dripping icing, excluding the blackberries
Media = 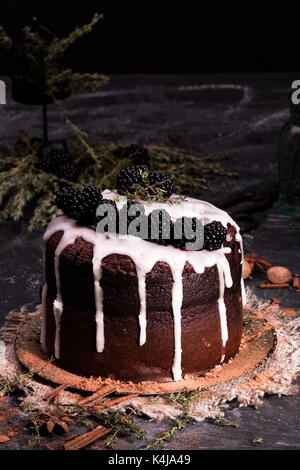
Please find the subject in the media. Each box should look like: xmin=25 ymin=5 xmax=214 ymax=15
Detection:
xmin=41 ymin=190 xmax=243 ymax=382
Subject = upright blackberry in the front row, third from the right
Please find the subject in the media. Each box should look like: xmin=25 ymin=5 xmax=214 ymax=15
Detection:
xmin=148 ymin=209 xmax=173 ymax=245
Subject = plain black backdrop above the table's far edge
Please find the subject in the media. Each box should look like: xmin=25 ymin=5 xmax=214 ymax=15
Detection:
xmin=0 ymin=0 xmax=300 ymax=75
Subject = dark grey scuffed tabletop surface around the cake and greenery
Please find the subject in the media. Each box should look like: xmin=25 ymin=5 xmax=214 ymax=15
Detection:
xmin=0 ymin=74 xmax=300 ymax=449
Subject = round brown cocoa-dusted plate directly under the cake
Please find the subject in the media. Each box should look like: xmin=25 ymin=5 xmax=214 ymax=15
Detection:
xmin=15 ymin=309 xmax=277 ymax=395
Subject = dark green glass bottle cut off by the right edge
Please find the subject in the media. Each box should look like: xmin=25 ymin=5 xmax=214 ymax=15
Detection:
xmin=279 ymin=102 xmax=300 ymax=216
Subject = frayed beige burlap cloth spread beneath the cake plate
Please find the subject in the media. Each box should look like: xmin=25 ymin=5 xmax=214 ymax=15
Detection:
xmin=0 ymin=288 xmax=300 ymax=421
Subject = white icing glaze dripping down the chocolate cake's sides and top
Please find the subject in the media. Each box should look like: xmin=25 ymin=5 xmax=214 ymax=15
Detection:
xmin=43 ymin=190 xmax=242 ymax=381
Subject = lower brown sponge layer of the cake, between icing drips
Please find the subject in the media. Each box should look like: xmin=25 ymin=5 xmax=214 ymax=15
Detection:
xmin=46 ymin=270 xmax=242 ymax=382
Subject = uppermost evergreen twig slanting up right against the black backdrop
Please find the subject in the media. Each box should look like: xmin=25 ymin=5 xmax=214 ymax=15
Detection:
xmin=46 ymin=13 xmax=103 ymax=62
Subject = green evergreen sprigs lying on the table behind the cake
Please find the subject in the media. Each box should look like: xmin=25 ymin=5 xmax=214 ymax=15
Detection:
xmin=0 ymin=137 xmax=237 ymax=230
